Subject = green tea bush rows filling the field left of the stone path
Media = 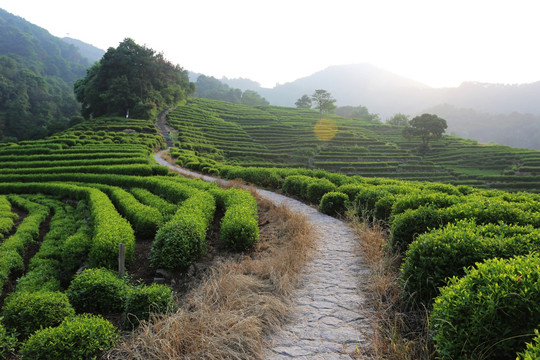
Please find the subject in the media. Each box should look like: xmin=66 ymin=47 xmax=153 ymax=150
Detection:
xmin=0 ymin=118 xmax=259 ymax=359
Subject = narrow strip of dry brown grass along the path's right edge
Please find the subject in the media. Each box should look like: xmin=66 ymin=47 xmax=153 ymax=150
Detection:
xmin=351 ymin=219 xmax=433 ymax=360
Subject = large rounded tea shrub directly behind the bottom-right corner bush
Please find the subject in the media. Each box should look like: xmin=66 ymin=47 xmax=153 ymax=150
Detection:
xmin=401 ymin=220 xmax=540 ymax=307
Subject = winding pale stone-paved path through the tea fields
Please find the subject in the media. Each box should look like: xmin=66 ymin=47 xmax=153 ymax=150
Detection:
xmin=155 ymin=150 xmax=373 ymax=360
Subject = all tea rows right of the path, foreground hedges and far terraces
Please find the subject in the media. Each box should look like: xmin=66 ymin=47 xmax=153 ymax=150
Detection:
xmin=165 ymin=99 xmax=540 ymax=359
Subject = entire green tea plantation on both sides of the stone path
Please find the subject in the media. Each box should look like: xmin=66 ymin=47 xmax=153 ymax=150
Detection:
xmin=0 ymin=99 xmax=540 ymax=359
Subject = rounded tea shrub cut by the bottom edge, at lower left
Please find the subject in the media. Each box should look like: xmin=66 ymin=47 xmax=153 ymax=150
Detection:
xmin=20 ymin=314 xmax=118 ymax=360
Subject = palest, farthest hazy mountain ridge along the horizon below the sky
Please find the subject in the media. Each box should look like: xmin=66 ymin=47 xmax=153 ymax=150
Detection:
xmin=222 ymin=63 xmax=540 ymax=119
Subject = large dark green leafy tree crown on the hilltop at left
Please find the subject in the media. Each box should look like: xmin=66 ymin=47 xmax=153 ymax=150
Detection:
xmin=74 ymin=38 xmax=195 ymax=119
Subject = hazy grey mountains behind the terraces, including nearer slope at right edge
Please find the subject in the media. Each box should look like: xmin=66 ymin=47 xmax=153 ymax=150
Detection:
xmin=222 ymin=64 xmax=540 ymax=150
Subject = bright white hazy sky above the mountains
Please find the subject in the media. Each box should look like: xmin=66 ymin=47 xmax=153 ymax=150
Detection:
xmin=0 ymin=0 xmax=540 ymax=87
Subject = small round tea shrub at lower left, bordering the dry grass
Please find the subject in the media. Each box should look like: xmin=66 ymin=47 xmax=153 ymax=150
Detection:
xmin=124 ymin=284 xmax=175 ymax=326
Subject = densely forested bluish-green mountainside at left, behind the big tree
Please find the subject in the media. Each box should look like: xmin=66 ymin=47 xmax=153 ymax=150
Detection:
xmin=0 ymin=9 xmax=90 ymax=141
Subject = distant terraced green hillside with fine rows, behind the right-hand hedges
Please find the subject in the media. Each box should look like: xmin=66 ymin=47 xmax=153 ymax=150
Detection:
xmin=169 ymin=99 xmax=540 ymax=191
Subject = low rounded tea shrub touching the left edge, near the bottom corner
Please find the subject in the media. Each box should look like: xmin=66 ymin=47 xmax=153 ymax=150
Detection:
xmin=2 ymin=291 xmax=75 ymax=339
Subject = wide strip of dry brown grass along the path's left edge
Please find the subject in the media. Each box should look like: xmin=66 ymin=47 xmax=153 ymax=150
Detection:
xmin=105 ymin=201 xmax=313 ymax=359
